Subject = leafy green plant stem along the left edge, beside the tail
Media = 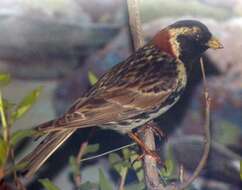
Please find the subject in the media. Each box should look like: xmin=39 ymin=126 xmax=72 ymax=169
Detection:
xmin=0 ymin=73 xmax=42 ymax=190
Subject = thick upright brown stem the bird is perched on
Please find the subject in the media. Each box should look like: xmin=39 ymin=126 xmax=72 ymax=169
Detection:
xmin=127 ymin=0 xmax=164 ymax=190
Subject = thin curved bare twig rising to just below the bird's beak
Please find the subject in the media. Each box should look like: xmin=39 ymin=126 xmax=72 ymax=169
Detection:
xmin=177 ymin=58 xmax=211 ymax=190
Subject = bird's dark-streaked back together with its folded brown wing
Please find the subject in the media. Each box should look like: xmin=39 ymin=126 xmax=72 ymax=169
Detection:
xmin=39 ymin=45 xmax=177 ymax=131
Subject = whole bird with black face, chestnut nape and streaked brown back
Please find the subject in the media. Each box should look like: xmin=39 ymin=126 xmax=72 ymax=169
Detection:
xmin=20 ymin=20 xmax=223 ymax=178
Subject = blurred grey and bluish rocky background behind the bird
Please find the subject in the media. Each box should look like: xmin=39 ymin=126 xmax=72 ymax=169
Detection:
xmin=0 ymin=0 xmax=242 ymax=190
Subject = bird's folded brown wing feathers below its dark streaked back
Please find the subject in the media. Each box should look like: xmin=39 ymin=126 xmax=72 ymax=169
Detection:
xmin=39 ymin=89 xmax=173 ymax=132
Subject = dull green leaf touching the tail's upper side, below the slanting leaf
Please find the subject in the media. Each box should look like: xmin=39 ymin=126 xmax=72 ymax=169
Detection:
xmin=10 ymin=129 xmax=38 ymax=146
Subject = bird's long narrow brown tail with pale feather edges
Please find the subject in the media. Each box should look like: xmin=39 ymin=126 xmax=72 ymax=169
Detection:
xmin=20 ymin=122 xmax=76 ymax=178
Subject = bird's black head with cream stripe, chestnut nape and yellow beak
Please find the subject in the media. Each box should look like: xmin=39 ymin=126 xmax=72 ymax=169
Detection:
xmin=152 ymin=20 xmax=223 ymax=62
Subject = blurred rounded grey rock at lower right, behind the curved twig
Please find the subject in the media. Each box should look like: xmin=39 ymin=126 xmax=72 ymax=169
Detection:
xmin=165 ymin=135 xmax=242 ymax=187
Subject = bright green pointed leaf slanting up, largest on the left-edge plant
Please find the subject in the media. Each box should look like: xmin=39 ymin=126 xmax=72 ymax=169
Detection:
xmin=11 ymin=87 xmax=43 ymax=121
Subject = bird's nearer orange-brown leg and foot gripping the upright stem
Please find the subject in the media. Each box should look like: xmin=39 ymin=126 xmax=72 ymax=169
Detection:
xmin=128 ymin=132 xmax=161 ymax=164
